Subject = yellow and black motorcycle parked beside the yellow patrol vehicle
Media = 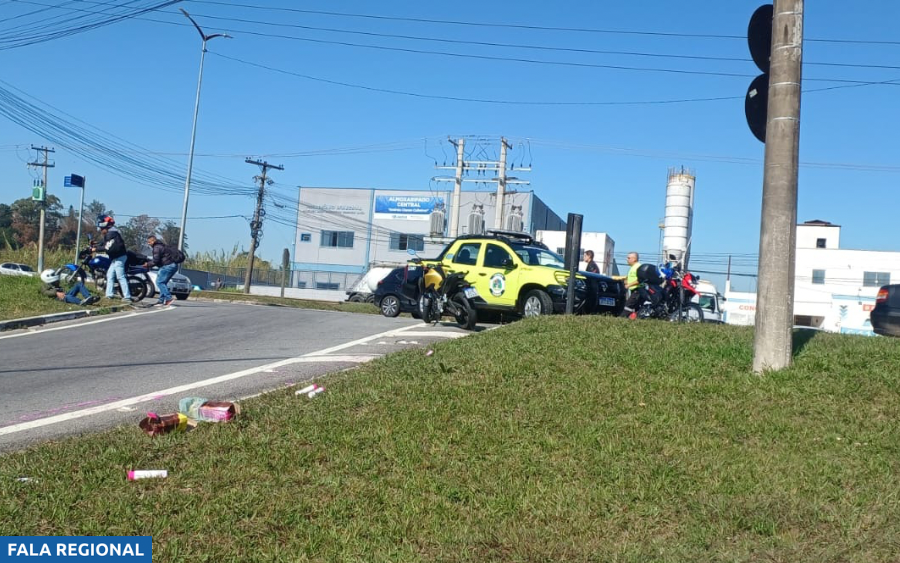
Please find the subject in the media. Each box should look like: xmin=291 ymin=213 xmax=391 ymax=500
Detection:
xmin=407 ymin=249 xmax=478 ymax=330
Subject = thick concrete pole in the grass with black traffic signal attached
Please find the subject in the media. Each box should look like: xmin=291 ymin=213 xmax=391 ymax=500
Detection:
xmin=753 ymin=0 xmax=803 ymax=373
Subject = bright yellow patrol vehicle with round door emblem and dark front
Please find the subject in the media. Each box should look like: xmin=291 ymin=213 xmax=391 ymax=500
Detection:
xmin=424 ymin=231 xmax=625 ymax=317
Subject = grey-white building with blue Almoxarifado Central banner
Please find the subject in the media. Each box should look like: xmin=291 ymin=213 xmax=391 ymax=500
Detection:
xmin=291 ymin=187 xmax=566 ymax=297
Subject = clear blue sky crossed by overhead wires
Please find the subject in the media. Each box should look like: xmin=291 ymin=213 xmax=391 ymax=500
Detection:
xmin=0 ymin=0 xmax=900 ymax=287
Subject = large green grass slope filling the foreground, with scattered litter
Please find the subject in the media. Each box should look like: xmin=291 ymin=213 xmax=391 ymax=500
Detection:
xmin=0 ymin=317 xmax=900 ymax=563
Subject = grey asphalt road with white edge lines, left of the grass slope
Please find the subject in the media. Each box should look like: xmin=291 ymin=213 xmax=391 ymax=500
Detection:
xmin=0 ymin=301 xmax=474 ymax=451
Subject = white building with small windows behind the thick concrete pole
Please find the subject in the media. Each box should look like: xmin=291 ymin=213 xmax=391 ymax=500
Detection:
xmin=725 ymin=220 xmax=900 ymax=335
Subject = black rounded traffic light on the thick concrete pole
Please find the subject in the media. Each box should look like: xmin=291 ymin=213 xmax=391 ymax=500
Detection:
xmin=744 ymin=4 xmax=775 ymax=143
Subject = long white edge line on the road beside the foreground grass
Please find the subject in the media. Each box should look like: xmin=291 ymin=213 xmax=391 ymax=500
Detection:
xmin=0 ymin=319 xmax=416 ymax=436
